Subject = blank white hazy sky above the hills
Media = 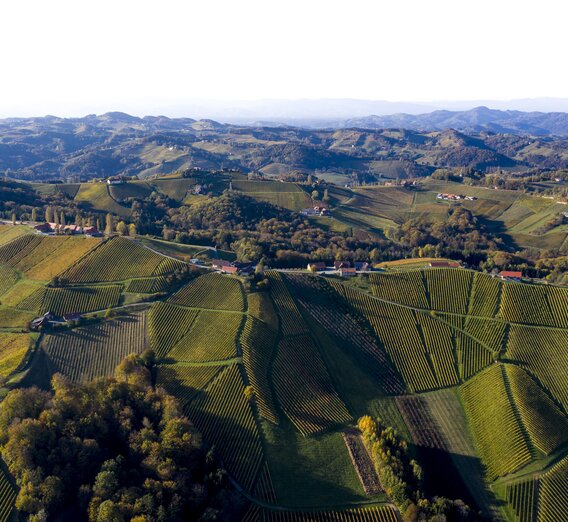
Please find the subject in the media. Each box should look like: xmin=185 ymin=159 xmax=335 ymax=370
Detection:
xmin=0 ymin=0 xmax=568 ymax=116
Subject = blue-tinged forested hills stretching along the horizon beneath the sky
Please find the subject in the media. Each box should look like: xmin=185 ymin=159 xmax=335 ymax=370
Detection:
xmin=0 ymin=108 xmax=568 ymax=183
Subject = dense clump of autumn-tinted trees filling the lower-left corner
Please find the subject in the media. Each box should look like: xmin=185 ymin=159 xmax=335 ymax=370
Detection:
xmin=0 ymin=354 xmax=239 ymax=522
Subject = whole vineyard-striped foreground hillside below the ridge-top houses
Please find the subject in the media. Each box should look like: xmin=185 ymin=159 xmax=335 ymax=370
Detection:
xmin=0 ymin=235 xmax=568 ymax=521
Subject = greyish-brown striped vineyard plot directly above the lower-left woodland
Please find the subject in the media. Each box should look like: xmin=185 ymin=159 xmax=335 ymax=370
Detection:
xmin=42 ymin=313 xmax=147 ymax=382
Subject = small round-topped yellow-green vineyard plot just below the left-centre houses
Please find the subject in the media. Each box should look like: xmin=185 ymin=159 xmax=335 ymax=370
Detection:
xmin=170 ymin=274 xmax=246 ymax=312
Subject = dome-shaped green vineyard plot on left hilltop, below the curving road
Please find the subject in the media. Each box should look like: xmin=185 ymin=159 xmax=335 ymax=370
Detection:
xmin=63 ymin=237 xmax=182 ymax=283
